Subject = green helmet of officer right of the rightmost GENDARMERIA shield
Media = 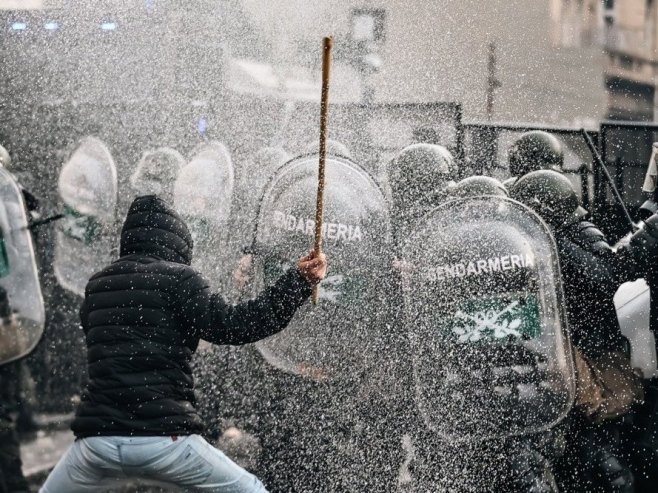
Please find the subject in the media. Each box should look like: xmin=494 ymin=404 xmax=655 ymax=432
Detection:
xmin=510 ymin=169 xmax=587 ymax=228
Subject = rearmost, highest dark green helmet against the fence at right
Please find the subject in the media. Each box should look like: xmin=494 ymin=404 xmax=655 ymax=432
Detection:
xmin=507 ymin=130 xmax=564 ymax=177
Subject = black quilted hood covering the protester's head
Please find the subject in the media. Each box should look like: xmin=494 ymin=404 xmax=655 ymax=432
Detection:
xmin=120 ymin=195 xmax=193 ymax=265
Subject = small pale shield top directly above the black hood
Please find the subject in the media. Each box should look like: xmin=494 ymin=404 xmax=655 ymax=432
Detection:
xmin=130 ymin=147 xmax=185 ymax=202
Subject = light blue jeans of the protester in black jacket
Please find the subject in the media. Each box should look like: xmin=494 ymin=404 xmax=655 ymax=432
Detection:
xmin=39 ymin=435 xmax=267 ymax=493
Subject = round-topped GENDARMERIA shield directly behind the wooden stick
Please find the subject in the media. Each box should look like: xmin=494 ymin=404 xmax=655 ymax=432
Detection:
xmin=249 ymin=155 xmax=390 ymax=381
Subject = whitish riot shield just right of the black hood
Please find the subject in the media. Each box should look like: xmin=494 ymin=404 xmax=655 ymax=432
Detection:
xmin=174 ymin=142 xmax=234 ymax=288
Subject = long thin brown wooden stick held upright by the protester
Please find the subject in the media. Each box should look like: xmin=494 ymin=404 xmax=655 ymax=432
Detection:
xmin=313 ymin=36 xmax=334 ymax=305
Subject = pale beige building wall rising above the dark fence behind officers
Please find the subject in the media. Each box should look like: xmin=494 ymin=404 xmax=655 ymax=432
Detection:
xmin=242 ymin=0 xmax=606 ymax=125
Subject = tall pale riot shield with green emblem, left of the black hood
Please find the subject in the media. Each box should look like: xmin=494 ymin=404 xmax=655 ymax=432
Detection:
xmin=54 ymin=137 xmax=117 ymax=295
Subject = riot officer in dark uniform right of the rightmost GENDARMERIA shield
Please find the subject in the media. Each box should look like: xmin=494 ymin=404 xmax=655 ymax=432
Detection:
xmin=511 ymin=170 xmax=658 ymax=491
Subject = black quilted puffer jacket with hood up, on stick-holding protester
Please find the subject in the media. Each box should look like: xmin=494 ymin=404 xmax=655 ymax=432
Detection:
xmin=72 ymin=196 xmax=311 ymax=437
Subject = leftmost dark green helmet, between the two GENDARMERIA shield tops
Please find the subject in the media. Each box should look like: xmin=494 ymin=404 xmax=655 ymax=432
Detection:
xmin=388 ymin=144 xmax=452 ymax=208
